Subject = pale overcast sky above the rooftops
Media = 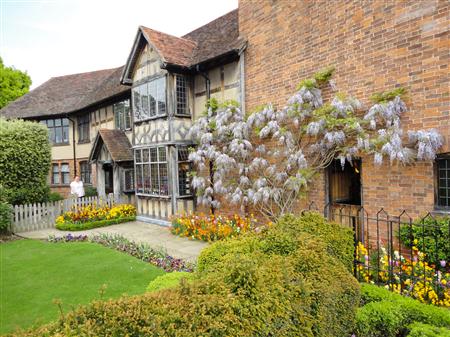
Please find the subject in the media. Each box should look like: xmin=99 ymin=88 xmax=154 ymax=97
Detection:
xmin=0 ymin=0 xmax=238 ymax=88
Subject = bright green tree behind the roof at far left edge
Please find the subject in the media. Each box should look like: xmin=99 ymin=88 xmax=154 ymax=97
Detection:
xmin=0 ymin=57 xmax=31 ymax=109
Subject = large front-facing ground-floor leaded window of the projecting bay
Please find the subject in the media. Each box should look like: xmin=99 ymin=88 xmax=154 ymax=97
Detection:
xmin=135 ymin=146 xmax=169 ymax=196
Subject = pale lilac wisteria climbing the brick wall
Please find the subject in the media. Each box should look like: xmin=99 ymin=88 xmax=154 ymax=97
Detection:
xmin=190 ymin=68 xmax=442 ymax=220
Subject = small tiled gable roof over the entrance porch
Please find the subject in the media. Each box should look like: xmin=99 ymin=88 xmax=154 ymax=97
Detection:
xmin=89 ymin=129 xmax=134 ymax=162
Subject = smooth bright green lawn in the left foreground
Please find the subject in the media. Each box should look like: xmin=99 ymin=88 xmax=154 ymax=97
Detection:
xmin=0 ymin=240 xmax=164 ymax=334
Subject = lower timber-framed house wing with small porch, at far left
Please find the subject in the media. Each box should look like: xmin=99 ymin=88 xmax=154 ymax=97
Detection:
xmin=0 ymin=67 xmax=134 ymax=199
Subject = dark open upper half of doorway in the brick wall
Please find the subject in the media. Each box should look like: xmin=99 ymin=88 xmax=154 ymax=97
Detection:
xmin=328 ymin=159 xmax=361 ymax=206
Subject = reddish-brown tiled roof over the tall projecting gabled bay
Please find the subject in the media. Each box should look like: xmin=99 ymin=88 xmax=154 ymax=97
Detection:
xmin=121 ymin=9 xmax=246 ymax=84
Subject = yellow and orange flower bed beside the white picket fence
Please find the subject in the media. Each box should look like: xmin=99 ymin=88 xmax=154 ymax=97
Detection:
xmin=56 ymin=204 xmax=136 ymax=231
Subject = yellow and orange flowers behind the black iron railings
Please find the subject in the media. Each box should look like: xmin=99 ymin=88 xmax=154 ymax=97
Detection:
xmin=356 ymin=242 xmax=450 ymax=307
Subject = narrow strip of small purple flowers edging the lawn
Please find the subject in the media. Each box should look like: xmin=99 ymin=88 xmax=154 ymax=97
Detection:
xmin=47 ymin=234 xmax=195 ymax=272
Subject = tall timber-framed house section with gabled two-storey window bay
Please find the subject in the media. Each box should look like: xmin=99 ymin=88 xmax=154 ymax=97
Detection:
xmin=121 ymin=10 xmax=246 ymax=223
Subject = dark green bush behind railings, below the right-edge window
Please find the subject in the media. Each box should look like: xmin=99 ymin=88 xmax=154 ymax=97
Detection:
xmin=400 ymin=217 xmax=450 ymax=266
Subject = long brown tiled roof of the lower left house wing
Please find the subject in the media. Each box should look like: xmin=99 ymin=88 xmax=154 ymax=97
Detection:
xmin=0 ymin=67 xmax=130 ymax=118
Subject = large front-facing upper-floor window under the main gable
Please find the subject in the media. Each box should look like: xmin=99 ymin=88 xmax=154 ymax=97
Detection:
xmin=131 ymin=74 xmax=168 ymax=123
